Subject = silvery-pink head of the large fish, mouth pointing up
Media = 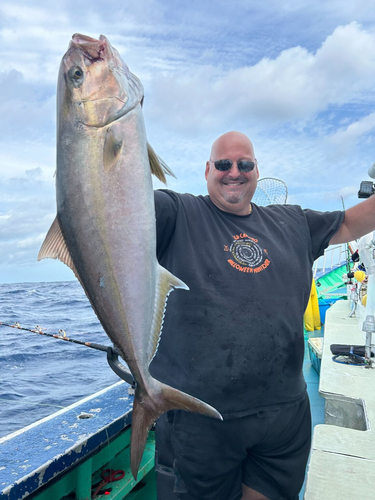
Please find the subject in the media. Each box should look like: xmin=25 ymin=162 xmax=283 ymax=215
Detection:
xmin=57 ymin=34 xmax=143 ymax=127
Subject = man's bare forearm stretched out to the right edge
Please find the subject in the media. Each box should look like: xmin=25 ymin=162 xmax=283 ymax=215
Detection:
xmin=329 ymin=196 xmax=375 ymax=245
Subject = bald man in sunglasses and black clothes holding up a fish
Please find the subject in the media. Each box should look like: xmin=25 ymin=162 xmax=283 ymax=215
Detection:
xmin=151 ymin=132 xmax=375 ymax=500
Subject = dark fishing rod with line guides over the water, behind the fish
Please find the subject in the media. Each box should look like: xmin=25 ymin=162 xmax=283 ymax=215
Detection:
xmin=0 ymin=321 xmax=135 ymax=387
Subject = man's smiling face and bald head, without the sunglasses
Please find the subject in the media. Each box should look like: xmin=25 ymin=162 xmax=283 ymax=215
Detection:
xmin=205 ymin=132 xmax=259 ymax=215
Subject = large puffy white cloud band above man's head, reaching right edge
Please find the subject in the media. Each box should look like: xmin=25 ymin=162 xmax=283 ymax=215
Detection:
xmin=146 ymin=23 xmax=375 ymax=134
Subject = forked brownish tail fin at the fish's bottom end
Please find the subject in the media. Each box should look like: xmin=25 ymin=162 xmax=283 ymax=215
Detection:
xmin=130 ymin=380 xmax=223 ymax=479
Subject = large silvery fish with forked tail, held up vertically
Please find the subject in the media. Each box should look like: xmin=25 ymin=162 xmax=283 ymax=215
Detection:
xmin=38 ymin=34 xmax=221 ymax=477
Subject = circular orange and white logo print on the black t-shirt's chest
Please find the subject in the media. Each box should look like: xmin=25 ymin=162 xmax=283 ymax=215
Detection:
xmin=224 ymin=233 xmax=271 ymax=273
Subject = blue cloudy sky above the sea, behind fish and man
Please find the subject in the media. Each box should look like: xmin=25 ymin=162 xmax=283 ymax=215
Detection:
xmin=0 ymin=0 xmax=375 ymax=283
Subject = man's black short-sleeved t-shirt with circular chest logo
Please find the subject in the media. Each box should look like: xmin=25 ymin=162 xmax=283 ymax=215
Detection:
xmin=150 ymin=190 xmax=344 ymax=417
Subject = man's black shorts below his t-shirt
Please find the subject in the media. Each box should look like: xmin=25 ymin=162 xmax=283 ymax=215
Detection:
xmin=155 ymin=394 xmax=311 ymax=500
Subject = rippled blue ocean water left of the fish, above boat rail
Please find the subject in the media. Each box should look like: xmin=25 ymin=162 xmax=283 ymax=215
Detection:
xmin=0 ymin=281 xmax=119 ymax=437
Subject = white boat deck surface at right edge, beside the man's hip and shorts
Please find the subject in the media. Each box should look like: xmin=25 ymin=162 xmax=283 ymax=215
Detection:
xmin=304 ymin=301 xmax=375 ymax=500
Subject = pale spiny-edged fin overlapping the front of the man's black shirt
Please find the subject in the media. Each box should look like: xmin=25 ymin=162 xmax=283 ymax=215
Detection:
xmin=148 ymin=266 xmax=189 ymax=363
